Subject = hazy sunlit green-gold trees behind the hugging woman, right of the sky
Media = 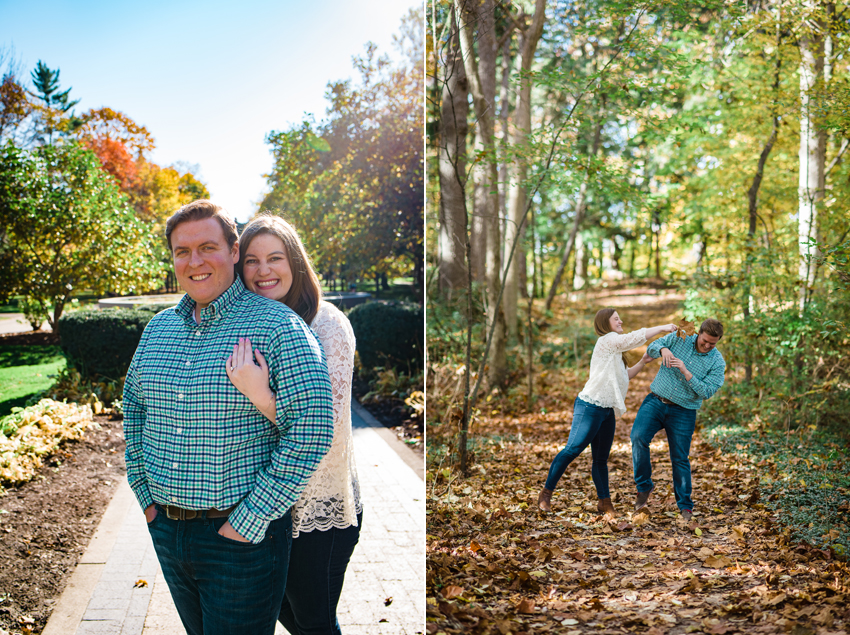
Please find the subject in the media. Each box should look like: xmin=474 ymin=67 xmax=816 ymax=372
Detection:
xmin=260 ymin=10 xmax=424 ymax=296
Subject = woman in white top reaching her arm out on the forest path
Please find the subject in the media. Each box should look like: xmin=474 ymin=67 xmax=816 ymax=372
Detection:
xmin=537 ymin=308 xmax=676 ymax=513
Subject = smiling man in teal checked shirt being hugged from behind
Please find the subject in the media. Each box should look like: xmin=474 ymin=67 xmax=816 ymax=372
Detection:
xmin=123 ymin=200 xmax=333 ymax=635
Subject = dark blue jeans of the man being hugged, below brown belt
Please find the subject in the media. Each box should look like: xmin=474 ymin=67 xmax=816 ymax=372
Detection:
xmin=148 ymin=505 xmax=292 ymax=635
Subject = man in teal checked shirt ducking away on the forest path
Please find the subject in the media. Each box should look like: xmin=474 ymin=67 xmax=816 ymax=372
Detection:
xmin=631 ymin=319 xmax=726 ymax=521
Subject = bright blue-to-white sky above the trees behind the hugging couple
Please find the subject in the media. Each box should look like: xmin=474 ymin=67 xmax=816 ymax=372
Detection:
xmin=0 ymin=0 xmax=418 ymax=220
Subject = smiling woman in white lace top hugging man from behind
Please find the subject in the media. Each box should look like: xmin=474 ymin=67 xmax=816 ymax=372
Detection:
xmin=227 ymin=216 xmax=363 ymax=635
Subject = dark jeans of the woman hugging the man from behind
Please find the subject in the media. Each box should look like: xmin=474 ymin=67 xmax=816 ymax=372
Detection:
xmin=278 ymin=513 xmax=363 ymax=635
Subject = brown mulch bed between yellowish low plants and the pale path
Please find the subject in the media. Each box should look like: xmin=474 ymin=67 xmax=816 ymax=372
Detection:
xmin=0 ymin=417 xmax=126 ymax=633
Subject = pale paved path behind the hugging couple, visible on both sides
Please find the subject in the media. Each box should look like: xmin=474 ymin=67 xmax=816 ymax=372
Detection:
xmin=43 ymin=402 xmax=425 ymax=635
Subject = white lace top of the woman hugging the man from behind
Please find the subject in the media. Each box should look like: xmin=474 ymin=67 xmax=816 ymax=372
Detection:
xmin=292 ymin=302 xmax=362 ymax=538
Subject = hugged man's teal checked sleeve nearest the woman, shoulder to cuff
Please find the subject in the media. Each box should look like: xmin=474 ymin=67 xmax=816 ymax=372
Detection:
xmin=228 ymin=318 xmax=333 ymax=543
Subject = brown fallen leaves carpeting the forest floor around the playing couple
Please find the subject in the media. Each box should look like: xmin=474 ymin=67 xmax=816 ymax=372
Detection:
xmin=427 ymin=291 xmax=850 ymax=635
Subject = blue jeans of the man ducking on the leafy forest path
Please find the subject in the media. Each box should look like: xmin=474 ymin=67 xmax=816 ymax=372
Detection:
xmin=631 ymin=393 xmax=697 ymax=510
